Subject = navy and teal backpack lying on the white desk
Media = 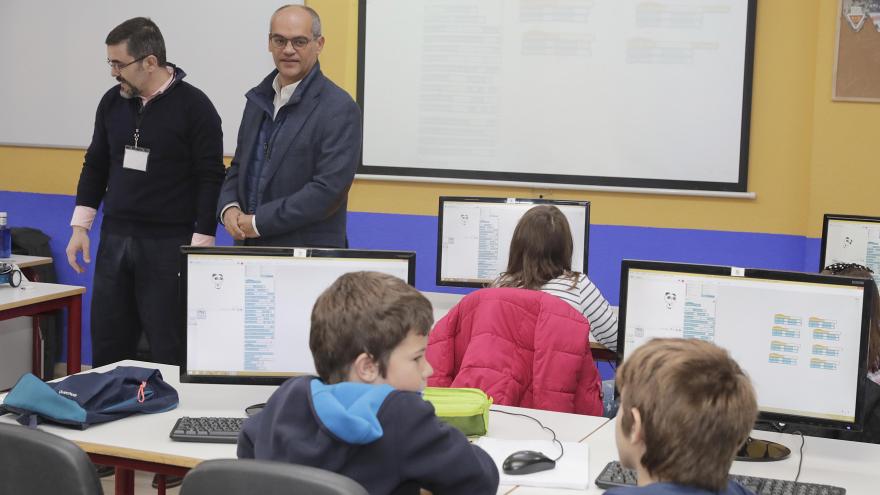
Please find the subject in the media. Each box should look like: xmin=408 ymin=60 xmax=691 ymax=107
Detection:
xmin=0 ymin=366 xmax=179 ymax=429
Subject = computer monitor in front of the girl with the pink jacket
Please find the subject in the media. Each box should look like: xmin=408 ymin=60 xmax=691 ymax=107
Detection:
xmin=437 ymin=196 xmax=590 ymax=287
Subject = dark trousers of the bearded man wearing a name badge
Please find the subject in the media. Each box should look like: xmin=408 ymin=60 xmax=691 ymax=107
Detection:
xmin=91 ymin=230 xmax=192 ymax=366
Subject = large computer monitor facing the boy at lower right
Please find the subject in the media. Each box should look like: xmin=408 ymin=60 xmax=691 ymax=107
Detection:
xmin=618 ymin=260 xmax=874 ymax=430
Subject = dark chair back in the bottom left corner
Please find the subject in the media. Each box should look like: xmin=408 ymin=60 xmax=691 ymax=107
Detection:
xmin=0 ymin=424 xmax=104 ymax=495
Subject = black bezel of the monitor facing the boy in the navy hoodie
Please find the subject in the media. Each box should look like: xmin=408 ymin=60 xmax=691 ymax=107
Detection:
xmin=178 ymin=246 xmax=416 ymax=385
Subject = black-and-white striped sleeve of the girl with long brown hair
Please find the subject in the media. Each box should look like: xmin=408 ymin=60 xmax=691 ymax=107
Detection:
xmin=541 ymin=274 xmax=617 ymax=351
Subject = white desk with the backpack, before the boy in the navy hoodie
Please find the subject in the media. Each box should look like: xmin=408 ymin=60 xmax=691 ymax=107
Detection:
xmin=0 ymin=360 xmax=608 ymax=494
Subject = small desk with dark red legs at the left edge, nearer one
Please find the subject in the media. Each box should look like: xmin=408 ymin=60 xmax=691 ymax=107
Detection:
xmin=0 ymin=282 xmax=86 ymax=374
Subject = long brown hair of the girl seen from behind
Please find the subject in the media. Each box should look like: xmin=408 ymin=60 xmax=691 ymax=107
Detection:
xmin=495 ymin=205 xmax=580 ymax=290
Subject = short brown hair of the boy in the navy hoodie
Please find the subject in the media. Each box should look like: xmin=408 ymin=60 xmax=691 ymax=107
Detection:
xmin=309 ymin=272 xmax=434 ymax=384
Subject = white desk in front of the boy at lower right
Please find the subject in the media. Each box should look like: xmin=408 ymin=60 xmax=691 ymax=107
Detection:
xmin=576 ymin=421 xmax=880 ymax=495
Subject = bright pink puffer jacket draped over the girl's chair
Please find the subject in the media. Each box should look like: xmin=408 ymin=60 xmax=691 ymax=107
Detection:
xmin=427 ymin=288 xmax=602 ymax=416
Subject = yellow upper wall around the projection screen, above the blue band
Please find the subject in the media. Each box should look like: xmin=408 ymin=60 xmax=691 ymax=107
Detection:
xmin=0 ymin=0 xmax=880 ymax=236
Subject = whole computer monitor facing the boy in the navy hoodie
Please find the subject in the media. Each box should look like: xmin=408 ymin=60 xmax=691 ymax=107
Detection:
xmin=180 ymin=247 xmax=415 ymax=385
